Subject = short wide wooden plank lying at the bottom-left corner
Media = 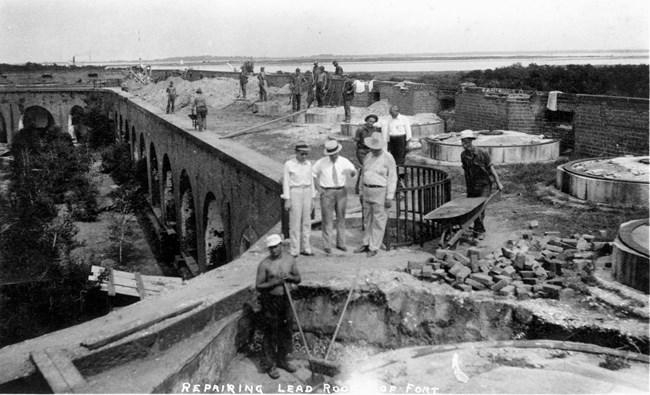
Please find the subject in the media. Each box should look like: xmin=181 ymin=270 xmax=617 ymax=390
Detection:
xmin=30 ymin=350 xmax=86 ymax=394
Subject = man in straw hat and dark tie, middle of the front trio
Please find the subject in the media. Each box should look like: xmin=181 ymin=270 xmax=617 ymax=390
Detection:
xmin=312 ymin=140 xmax=357 ymax=254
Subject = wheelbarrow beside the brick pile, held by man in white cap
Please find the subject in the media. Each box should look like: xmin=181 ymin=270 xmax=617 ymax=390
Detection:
xmin=424 ymin=191 xmax=499 ymax=248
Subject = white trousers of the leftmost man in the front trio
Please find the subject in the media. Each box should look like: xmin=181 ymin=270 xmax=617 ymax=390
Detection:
xmin=289 ymin=186 xmax=312 ymax=256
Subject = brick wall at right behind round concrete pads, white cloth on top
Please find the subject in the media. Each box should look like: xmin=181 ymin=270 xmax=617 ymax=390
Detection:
xmin=451 ymin=87 xmax=650 ymax=156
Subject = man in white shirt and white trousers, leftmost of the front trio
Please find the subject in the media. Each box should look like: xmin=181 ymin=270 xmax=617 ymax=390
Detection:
xmin=282 ymin=142 xmax=316 ymax=256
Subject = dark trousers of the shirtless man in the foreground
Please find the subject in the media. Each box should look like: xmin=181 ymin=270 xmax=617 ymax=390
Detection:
xmin=260 ymin=294 xmax=293 ymax=369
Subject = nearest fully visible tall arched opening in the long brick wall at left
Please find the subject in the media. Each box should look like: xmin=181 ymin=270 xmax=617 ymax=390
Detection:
xmin=203 ymin=193 xmax=228 ymax=270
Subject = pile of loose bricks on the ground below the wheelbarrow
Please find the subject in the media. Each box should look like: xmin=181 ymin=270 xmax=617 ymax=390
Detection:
xmin=407 ymin=232 xmax=609 ymax=300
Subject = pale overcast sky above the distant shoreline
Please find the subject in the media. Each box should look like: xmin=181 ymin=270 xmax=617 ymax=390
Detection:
xmin=0 ymin=0 xmax=650 ymax=63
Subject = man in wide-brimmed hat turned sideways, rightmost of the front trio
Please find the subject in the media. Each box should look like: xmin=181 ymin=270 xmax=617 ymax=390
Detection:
xmin=354 ymin=132 xmax=397 ymax=257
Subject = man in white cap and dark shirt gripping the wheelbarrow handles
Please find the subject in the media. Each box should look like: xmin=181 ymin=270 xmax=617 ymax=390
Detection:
xmin=460 ymin=130 xmax=503 ymax=240
